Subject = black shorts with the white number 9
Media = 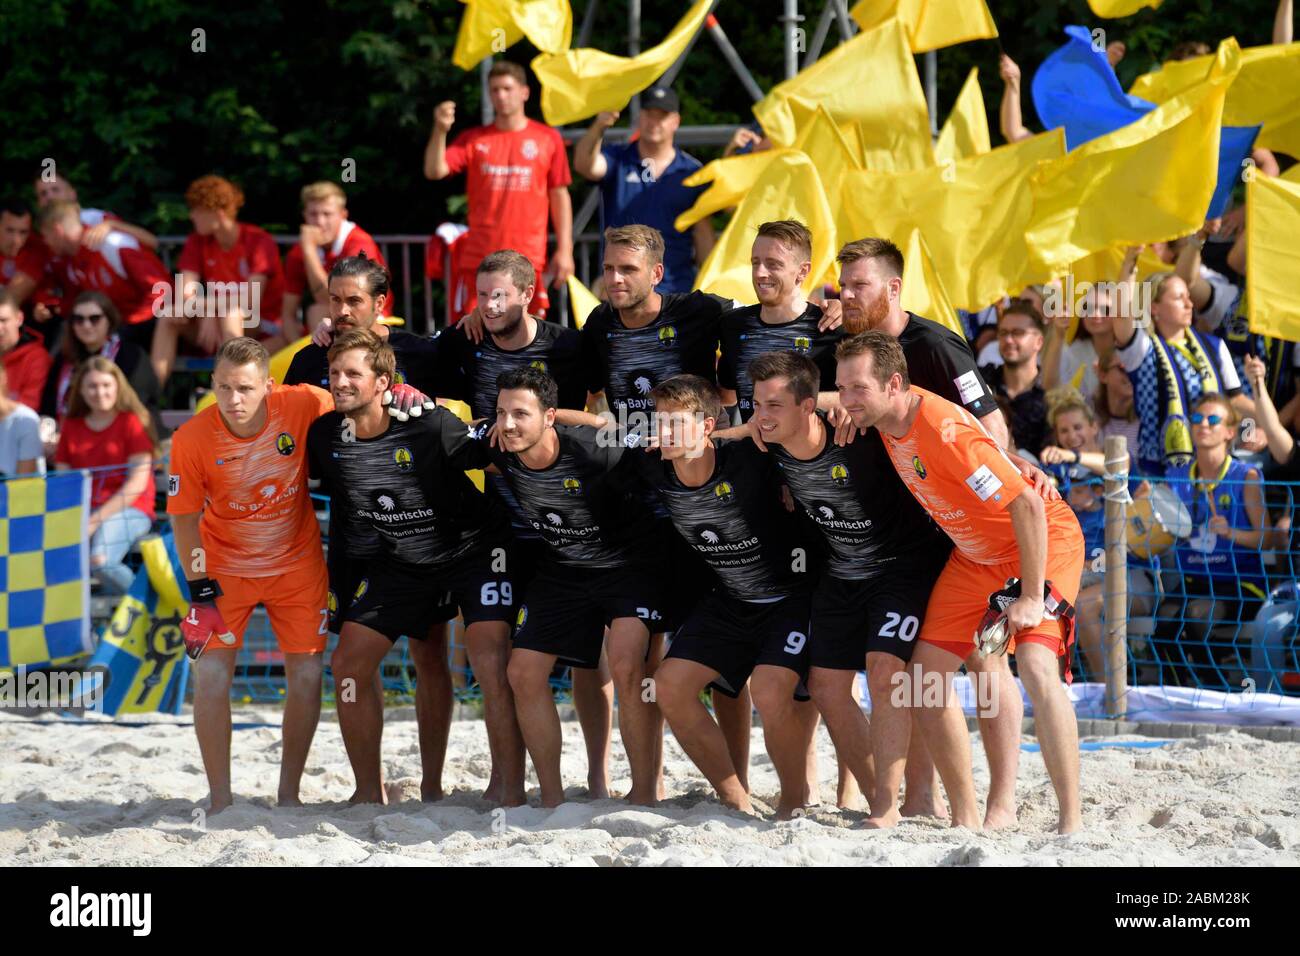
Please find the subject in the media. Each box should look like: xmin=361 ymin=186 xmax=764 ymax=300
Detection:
xmin=666 ymin=592 xmax=811 ymax=700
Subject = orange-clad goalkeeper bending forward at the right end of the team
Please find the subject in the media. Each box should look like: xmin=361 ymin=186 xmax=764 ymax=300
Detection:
xmin=836 ymin=332 xmax=1084 ymax=832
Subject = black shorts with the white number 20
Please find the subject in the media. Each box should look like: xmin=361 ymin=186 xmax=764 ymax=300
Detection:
xmin=809 ymin=554 xmax=948 ymax=671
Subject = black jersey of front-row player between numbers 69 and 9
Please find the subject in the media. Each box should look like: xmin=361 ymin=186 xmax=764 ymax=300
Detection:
xmin=462 ymin=421 xmax=659 ymax=568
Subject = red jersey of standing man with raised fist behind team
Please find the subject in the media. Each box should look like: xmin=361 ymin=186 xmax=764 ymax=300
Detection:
xmin=447 ymin=120 xmax=572 ymax=272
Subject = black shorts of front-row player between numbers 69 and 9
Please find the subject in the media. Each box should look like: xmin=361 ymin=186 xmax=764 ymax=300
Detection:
xmin=515 ymin=561 xmax=664 ymax=669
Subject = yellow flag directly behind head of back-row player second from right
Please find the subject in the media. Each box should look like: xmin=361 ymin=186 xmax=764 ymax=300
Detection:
xmin=696 ymin=150 xmax=836 ymax=302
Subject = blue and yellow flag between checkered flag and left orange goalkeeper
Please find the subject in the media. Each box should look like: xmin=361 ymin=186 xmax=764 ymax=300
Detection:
xmin=88 ymin=535 xmax=190 ymax=717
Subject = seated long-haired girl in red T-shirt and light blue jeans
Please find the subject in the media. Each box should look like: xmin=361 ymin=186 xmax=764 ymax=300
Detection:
xmin=55 ymin=355 xmax=157 ymax=594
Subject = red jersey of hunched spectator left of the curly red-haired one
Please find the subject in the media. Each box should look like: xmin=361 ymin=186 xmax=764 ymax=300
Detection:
xmin=49 ymin=232 xmax=172 ymax=325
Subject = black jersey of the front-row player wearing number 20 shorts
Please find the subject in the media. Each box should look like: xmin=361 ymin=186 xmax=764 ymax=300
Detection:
xmin=768 ymin=411 xmax=952 ymax=580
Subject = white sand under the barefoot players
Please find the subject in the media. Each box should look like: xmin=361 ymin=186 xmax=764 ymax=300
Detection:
xmin=0 ymin=708 xmax=1300 ymax=866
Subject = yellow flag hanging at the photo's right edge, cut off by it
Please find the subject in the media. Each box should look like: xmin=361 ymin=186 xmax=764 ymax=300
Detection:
xmin=1245 ymin=176 xmax=1300 ymax=342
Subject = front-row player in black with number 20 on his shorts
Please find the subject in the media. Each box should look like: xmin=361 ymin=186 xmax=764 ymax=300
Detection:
xmin=749 ymin=351 xmax=950 ymax=827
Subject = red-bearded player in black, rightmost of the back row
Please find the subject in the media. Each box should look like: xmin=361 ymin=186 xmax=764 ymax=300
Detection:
xmin=836 ymin=238 xmax=1060 ymax=827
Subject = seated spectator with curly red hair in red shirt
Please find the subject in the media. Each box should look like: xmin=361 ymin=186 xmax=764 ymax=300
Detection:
xmin=151 ymin=176 xmax=285 ymax=381
